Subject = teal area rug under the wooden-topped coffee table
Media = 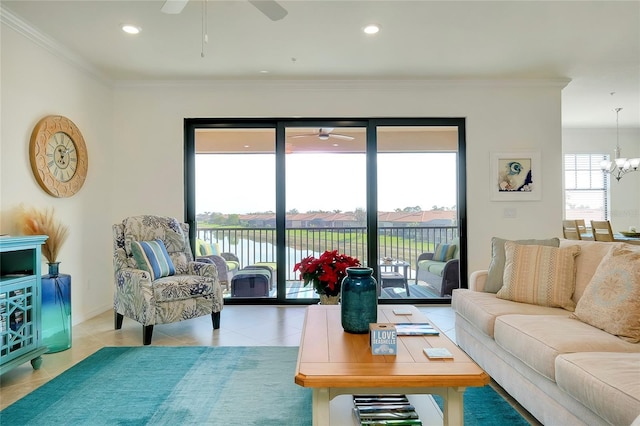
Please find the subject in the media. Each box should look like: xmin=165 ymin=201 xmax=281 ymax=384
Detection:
xmin=0 ymin=346 xmax=528 ymax=426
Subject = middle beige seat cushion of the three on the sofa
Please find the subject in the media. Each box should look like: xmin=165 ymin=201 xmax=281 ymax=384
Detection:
xmin=494 ymin=315 xmax=640 ymax=381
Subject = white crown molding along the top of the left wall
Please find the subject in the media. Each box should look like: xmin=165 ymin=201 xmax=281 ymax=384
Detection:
xmin=0 ymin=3 xmax=113 ymax=86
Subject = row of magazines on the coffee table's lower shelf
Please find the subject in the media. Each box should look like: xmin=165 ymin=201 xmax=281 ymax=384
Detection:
xmin=353 ymin=395 xmax=422 ymax=426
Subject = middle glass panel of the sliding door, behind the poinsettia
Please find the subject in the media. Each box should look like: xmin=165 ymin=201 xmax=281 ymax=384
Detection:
xmin=285 ymin=127 xmax=367 ymax=299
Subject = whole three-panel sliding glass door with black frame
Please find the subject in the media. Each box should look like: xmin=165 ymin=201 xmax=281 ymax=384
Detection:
xmin=185 ymin=118 xmax=466 ymax=304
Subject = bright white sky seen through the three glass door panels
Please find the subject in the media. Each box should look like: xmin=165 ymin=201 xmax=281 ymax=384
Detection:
xmin=196 ymin=153 xmax=456 ymax=214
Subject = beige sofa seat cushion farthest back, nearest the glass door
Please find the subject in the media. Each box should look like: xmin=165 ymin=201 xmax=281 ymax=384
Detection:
xmin=451 ymin=289 xmax=571 ymax=338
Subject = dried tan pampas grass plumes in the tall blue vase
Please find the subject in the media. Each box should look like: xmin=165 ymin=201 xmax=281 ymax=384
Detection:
xmin=17 ymin=206 xmax=69 ymax=263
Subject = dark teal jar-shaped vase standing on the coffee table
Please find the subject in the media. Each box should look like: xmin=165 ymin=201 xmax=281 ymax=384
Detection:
xmin=340 ymin=267 xmax=378 ymax=333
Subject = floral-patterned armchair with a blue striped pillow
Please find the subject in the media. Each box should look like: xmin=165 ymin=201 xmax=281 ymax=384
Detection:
xmin=113 ymin=215 xmax=223 ymax=345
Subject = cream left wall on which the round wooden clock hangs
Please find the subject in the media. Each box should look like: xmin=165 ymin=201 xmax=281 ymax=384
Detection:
xmin=0 ymin=25 xmax=114 ymax=323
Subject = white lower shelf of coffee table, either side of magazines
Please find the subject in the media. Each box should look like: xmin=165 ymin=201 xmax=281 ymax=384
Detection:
xmin=330 ymin=394 xmax=444 ymax=426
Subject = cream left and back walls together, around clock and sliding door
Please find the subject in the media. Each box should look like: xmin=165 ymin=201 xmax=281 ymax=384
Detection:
xmin=5 ymin=18 xmax=565 ymax=323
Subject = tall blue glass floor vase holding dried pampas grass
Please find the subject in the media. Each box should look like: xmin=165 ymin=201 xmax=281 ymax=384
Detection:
xmin=18 ymin=207 xmax=71 ymax=353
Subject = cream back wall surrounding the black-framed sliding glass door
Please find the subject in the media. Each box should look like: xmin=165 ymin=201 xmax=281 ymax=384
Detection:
xmin=113 ymin=81 xmax=563 ymax=271
